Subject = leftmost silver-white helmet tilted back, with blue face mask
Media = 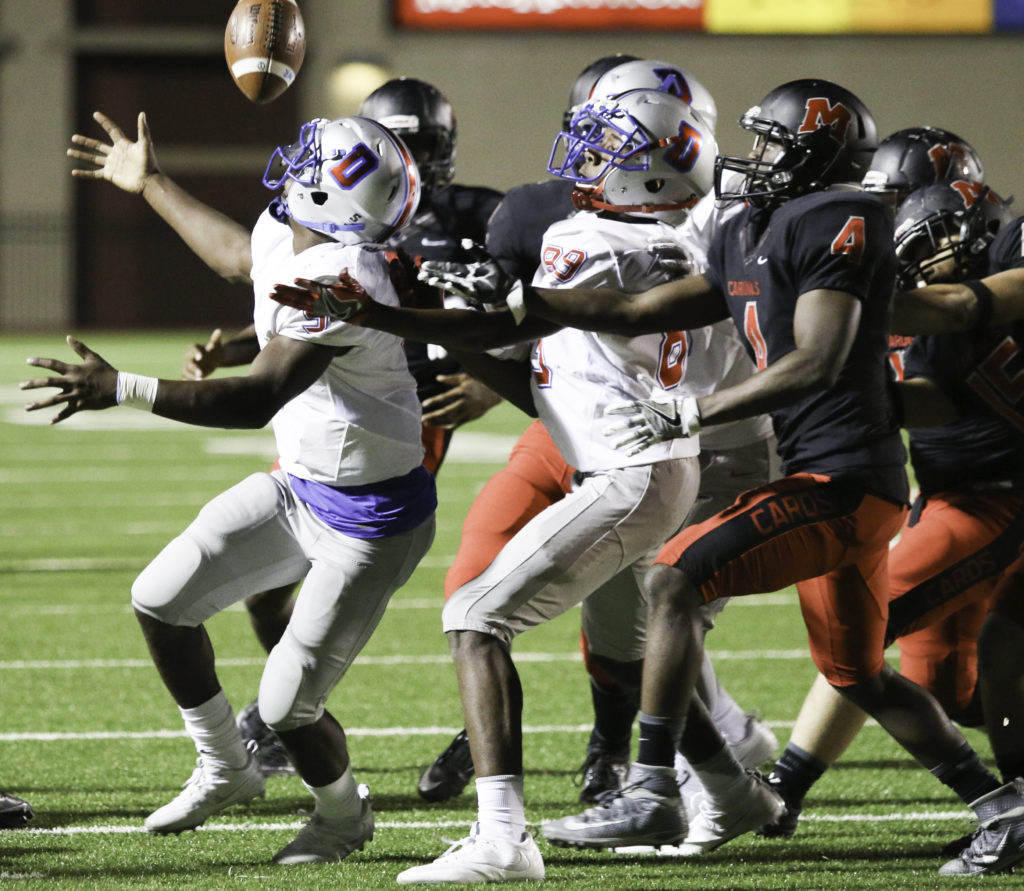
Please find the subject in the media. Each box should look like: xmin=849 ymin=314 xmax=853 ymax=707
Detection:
xmin=263 ymin=117 xmax=420 ymax=245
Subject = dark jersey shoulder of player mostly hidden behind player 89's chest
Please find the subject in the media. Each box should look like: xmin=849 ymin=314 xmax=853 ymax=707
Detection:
xmin=486 ymin=179 xmax=575 ymax=282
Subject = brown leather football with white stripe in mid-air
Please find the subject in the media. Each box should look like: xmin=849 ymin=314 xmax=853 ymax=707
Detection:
xmin=224 ymin=0 xmax=306 ymax=104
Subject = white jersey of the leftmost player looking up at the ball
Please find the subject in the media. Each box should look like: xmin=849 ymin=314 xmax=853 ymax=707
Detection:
xmin=252 ymin=211 xmax=423 ymax=486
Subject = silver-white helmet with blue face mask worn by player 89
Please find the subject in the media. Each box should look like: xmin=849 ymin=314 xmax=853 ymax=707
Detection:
xmin=548 ymin=90 xmax=718 ymax=224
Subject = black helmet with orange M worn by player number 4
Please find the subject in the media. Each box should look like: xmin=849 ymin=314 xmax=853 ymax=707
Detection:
xmin=715 ymin=80 xmax=879 ymax=207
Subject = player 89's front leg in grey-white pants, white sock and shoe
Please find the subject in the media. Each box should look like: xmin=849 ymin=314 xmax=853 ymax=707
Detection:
xmin=398 ymin=459 xmax=697 ymax=883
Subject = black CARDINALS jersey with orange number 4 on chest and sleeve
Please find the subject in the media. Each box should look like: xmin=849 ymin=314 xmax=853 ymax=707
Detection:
xmin=707 ymin=190 xmax=907 ymax=501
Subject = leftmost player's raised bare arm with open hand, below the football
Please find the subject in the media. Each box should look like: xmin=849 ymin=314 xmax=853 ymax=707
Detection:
xmin=68 ymin=112 xmax=252 ymax=283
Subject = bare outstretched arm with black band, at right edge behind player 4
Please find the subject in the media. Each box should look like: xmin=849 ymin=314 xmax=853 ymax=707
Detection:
xmin=892 ymin=268 xmax=1024 ymax=334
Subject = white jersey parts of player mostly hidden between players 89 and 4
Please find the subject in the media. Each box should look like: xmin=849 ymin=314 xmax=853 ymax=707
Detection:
xmin=675 ymin=174 xmax=772 ymax=451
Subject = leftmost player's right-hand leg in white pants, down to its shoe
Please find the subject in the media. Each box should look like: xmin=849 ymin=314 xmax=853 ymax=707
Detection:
xmin=259 ymin=516 xmax=434 ymax=864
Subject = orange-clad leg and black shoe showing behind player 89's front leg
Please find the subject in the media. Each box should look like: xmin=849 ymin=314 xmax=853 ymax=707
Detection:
xmin=417 ymin=421 xmax=572 ymax=802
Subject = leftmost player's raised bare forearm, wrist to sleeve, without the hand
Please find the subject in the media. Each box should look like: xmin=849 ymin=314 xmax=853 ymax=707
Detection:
xmin=142 ymin=173 xmax=252 ymax=283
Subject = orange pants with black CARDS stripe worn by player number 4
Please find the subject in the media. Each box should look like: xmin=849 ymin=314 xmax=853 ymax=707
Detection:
xmin=655 ymin=473 xmax=906 ymax=686
